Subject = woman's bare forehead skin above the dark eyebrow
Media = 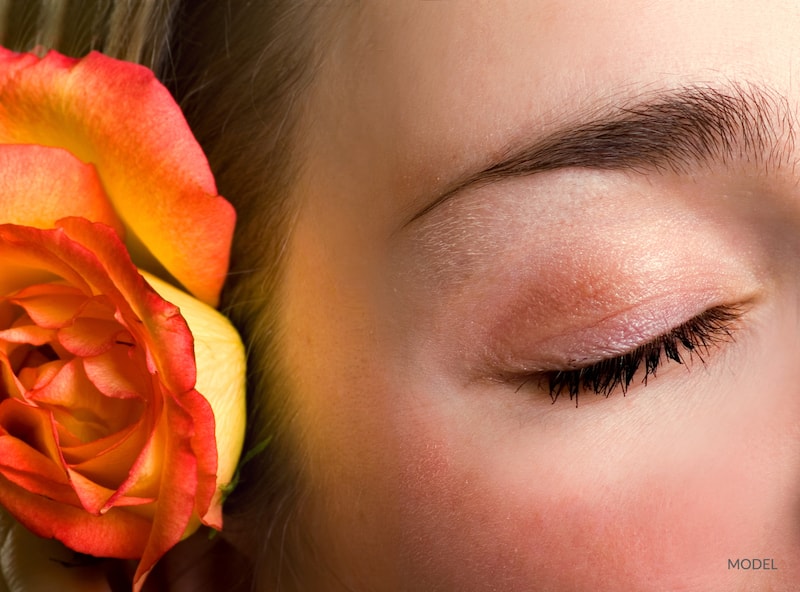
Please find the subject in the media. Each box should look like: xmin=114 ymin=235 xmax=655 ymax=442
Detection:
xmin=312 ymin=0 xmax=800 ymax=215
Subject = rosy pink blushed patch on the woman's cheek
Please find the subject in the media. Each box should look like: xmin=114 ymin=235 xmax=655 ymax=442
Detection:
xmin=400 ymin=424 xmax=732 ymax=591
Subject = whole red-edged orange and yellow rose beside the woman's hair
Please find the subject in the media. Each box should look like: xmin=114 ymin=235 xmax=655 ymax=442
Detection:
xmin=0 ymin=52 xmax=244 ymax=587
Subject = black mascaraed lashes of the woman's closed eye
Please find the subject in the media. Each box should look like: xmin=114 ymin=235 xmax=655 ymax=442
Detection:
xmin=526 ymin=306 xmax=742 ymax=407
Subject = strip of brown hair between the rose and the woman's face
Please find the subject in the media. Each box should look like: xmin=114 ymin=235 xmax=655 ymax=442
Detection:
xmin=166 ymin=0 xmax=332 ymax=590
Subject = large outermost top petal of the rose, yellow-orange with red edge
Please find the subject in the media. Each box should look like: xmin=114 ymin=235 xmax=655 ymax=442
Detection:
xmin=0 ymin=50 xmax=235 ymax=305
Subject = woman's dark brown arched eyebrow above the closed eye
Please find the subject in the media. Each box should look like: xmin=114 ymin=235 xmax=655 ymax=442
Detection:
xmin=405 ymin=84 xmax=794 ymax=225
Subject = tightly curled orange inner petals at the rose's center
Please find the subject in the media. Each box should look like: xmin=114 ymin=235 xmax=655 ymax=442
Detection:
xmin=0 ymin=283 xmax=143 ymax=444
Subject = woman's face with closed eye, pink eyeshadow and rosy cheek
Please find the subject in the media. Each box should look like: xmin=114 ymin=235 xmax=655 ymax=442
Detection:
xmin=285 ymin=0 xmax=800 ymax=591
